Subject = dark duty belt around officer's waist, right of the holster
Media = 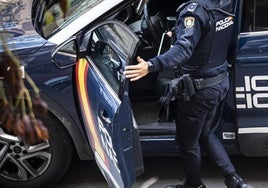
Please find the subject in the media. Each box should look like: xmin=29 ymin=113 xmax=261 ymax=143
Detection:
xmin=193 ymin=71 xmax=228 ymax=89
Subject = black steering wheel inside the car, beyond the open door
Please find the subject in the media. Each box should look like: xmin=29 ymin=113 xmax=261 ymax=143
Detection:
xmin=143 ymin=1 xmax=170 ymax=49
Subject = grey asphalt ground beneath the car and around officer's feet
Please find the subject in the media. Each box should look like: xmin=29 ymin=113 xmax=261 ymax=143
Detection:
xmin=55 ymin=156 xmax=268 ymax=188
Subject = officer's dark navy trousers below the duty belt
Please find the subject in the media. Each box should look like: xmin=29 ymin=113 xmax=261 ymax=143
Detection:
xmin=176 ymin=79 xmax=235 ymax=186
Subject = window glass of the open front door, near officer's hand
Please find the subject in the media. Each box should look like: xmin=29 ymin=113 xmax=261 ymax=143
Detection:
xmin=88 ymin=23 xmax=137 ymax=95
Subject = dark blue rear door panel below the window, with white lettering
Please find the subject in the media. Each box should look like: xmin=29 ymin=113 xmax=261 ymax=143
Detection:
xmin=235 ymin=33 xmax=268 ymax=153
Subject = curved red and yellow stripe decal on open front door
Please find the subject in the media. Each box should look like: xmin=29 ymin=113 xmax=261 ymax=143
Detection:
xmin=75 ymin=58 xmax=109 ymax=166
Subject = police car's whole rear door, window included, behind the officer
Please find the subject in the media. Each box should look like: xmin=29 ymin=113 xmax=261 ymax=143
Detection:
xmin=234 ymin=0 xmax=268 ymax=156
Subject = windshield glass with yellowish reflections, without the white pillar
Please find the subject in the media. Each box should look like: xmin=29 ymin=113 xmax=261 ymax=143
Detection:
xmin=41 ymin=0 xmax=104 ymax=37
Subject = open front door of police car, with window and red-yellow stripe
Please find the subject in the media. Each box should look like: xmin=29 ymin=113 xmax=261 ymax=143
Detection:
xmin=53 ymin=21 xmax=143 ymax=188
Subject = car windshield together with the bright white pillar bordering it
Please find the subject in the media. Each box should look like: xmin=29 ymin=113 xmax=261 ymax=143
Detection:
xmin=32 ymin=0 xmax=131 ymax=44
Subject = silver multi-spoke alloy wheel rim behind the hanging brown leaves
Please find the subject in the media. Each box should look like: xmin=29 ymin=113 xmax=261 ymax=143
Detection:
xmin=0 ymin=128 xmax=52 ymax=181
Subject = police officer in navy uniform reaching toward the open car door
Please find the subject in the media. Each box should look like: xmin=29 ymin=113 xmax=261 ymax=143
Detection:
xmin=125 ymin=0 xmax=254 ymax=188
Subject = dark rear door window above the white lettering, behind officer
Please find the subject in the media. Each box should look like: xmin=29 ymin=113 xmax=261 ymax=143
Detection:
xmin=242 ymin=0 xmax=268 ymax=32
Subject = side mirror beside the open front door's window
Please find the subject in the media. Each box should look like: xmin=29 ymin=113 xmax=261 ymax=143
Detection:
xmin=51 ymin=37 xmax=78 ymax=69
